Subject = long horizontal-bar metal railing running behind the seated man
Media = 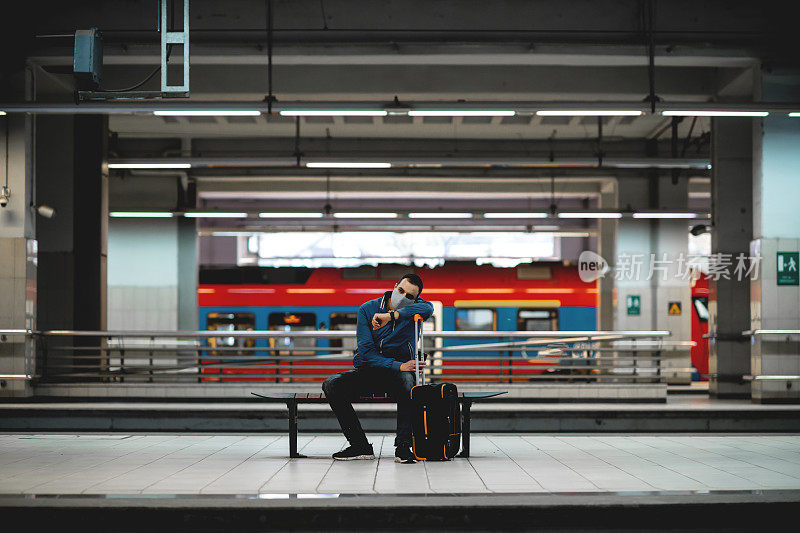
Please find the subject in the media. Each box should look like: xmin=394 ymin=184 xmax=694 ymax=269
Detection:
xmin=0 ymin=330 xmax=694 ymax=383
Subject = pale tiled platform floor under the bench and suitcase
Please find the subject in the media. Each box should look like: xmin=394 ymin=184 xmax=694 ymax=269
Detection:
xmin=0 ymin=434 xmax=800 ymax=494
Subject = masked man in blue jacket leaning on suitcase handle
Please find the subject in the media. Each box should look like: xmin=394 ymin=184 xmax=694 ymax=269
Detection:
xmin=322 ymin=274 xmax=433 ymax=463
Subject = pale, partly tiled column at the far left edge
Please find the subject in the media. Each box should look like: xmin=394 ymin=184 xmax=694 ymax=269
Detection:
xmin=0 ymin=115 xmax=38 ymax=397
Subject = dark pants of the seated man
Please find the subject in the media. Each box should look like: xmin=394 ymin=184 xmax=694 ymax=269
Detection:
xmin=322 ymin=367 xmax=416 ymax=447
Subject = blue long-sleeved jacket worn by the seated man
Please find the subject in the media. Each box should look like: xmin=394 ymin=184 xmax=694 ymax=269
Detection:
xmin=353 ymin=291 xmax=433 ymax=371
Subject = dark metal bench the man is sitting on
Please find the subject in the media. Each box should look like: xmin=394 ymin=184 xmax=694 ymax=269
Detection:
xmin=251 ymin=391 xmax=506 ymax=458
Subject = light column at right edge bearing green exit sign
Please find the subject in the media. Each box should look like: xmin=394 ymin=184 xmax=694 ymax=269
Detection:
xmin=750 ymin=70 xmax=800 ymax=402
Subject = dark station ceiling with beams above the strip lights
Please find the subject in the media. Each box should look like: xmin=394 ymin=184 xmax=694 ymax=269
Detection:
xmin=6 ymin=0 xmax=796 ymax=227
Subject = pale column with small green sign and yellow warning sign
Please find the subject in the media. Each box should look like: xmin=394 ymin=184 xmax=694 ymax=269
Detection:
xmin=615 ymin=174 xmax=692 ymax=384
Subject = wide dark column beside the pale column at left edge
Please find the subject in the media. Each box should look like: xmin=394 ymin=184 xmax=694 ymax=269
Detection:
xmin=35 ymin=115 xmax=108 ymax=380
